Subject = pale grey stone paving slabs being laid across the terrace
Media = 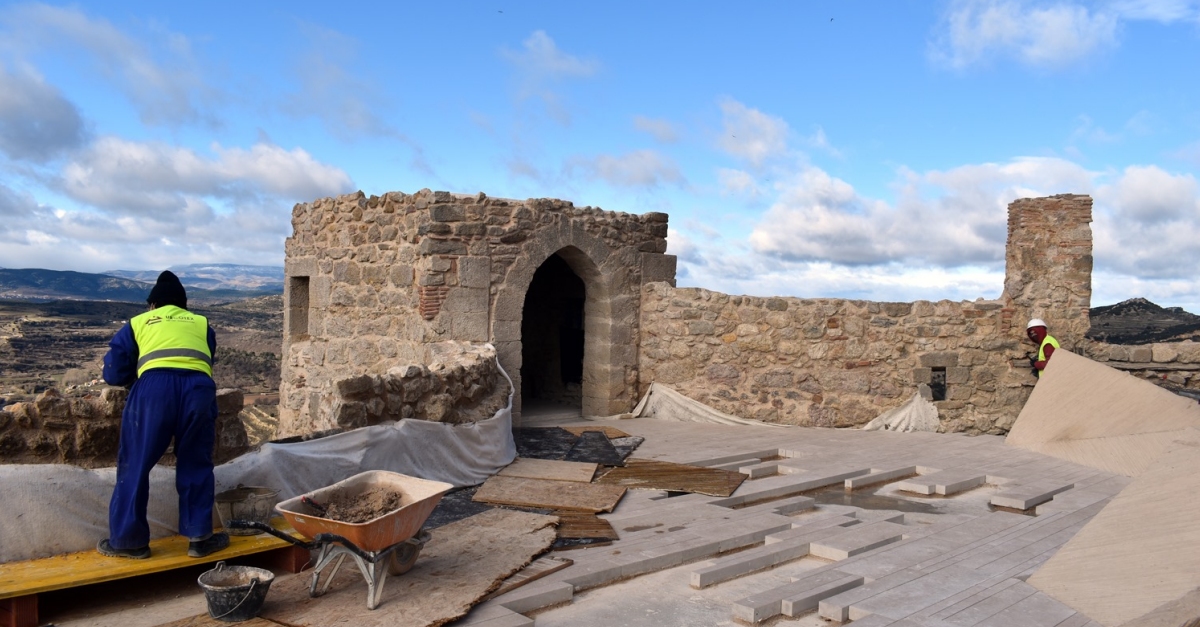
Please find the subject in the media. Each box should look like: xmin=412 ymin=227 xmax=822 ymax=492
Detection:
xmin=460 ymin=419 xmax=1128 ymax=627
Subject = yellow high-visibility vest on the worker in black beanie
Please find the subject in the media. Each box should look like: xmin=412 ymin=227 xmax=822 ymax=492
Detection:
xmin=130 ymin=305 xmax=212 ymax=376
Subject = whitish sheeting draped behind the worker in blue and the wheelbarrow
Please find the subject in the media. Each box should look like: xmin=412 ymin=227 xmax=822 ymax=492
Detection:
xmin=0 ymin=355 xmax=517 ymax=563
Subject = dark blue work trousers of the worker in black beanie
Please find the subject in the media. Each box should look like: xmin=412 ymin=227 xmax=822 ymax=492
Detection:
xmin=108 ymin=368 xmax=217 ymax=549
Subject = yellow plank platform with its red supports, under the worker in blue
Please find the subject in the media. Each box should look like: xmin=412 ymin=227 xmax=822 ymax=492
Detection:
xmin=0 ymin=518 xmax=308 ymax=627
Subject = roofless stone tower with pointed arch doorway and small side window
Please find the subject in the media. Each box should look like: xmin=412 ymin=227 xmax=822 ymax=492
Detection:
xmin=280 ymin=190 xmax=674 ymax=436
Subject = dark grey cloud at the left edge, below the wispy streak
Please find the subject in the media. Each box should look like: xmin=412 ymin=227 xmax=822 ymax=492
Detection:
xmin=0 ymin=62 xmax=86 ymax=162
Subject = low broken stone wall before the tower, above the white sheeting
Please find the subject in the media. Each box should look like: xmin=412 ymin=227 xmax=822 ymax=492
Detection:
xmin=322 ymin=342 xmax=511 ymax=429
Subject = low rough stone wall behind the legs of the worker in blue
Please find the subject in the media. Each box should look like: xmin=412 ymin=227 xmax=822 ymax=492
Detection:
xmin=0 ymin=388 xmax=248 ymax=467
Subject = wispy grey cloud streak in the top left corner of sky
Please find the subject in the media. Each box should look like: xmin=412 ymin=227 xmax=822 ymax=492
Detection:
xmin=0 ymin=2 xmax=214 ymax=125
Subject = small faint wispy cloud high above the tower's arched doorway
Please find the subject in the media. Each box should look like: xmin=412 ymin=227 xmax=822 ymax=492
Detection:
xmin=500 ymin=30 xmax=600 ymax=125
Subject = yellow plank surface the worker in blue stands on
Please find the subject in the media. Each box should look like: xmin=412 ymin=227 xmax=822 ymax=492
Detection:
xmin=0 ymin=518 xmax=299 ymax=599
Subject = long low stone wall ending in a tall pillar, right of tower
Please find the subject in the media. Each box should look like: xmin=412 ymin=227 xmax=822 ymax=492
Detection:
xmin=640 ymin=196 xmax=1092 ymax=434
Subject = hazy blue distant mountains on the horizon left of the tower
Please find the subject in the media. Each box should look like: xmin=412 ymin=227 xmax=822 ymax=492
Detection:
xmin=0 ymin=264 xmax=283 ymax=303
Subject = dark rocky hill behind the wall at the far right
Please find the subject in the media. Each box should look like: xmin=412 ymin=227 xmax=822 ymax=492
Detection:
xmin=1087 ymin=298 xmax=1200 ymax=344
